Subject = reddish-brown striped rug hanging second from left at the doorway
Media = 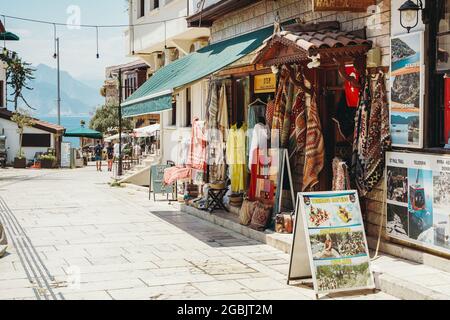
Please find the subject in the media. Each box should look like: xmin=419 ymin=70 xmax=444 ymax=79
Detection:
xmin=288 ymin=90 xmax=306 ymax=155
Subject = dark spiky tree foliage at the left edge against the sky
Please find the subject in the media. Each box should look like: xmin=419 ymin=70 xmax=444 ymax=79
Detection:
xmin=0 ymin=53 xmax=36 ymax=111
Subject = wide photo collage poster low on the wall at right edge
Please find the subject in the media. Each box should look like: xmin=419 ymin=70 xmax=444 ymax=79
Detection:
xmin=386 ymin=152 xmax=450 ymax=254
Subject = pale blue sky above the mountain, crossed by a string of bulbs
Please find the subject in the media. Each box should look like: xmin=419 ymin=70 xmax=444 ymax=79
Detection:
xmin=0 ymin=0 xmax=133 ymax=87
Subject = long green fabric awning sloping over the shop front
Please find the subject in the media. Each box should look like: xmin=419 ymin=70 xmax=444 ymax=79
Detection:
xmin=122 ymin=27 xmax=273 ymax=117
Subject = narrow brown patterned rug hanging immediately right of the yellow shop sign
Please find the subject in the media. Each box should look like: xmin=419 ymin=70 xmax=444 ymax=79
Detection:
xmin=271 ymin=68 xmax=289 ymax=148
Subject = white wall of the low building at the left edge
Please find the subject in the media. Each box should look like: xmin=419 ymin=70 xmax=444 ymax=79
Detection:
xmin=0 ymin=119 xmax=55 ymax=163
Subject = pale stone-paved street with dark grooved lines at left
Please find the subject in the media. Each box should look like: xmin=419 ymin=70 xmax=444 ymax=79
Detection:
xmin=0 ymin=166 xmax=392 ymax=300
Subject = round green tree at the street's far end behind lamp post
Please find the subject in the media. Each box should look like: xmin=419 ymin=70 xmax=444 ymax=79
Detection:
xmin=89 ymin=105 xmax=133 ymax=133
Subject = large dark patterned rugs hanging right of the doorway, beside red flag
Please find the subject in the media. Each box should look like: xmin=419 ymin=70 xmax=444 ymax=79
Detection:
xmin=352 ymin=75 xmax=391 ymax=197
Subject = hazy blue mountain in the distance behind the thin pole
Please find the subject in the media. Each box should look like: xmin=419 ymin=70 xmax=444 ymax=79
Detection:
xmin=16 ymin=64 xmax=104 ymax=116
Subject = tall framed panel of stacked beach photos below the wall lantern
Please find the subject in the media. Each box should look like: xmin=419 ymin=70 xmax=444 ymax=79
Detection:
xmin=390 ymin=31 xmax=425 ymax=148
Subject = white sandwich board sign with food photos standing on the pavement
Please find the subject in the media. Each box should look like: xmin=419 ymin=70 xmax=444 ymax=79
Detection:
xmin=288 ymin=190 xmax=375 ymax=295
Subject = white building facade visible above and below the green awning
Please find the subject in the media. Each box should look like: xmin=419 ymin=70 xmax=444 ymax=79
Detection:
xmin=126 ymin=0 xmax=210 ymax=163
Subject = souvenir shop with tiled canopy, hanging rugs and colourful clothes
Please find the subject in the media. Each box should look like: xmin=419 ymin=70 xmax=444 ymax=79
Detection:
xmin=164 ymin=22 xmax=390 ymax=233
